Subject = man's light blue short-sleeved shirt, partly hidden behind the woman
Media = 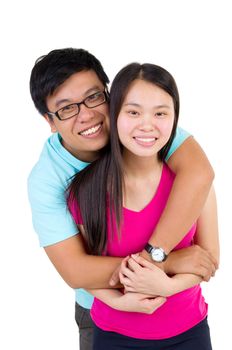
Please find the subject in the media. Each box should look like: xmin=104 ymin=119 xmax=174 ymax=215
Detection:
xmin=28 ymin=128 xmax=190 ymax=308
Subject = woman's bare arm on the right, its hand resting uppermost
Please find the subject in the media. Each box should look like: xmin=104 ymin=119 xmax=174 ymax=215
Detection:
xmin=120 ymin=188 xmax=219 ymax=296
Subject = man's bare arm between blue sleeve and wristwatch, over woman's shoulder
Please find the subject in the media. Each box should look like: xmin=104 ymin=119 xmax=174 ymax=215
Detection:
xmin=142 ymin=137 xmax=214 ymax=258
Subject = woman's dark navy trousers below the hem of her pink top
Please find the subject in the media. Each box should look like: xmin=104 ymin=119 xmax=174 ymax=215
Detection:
xmin=93 ymin=319 xmax=212 ymax=350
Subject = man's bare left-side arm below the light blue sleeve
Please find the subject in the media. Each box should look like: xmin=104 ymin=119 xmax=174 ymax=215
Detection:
xmin=45 ymin=233 xmax=122 ymax=288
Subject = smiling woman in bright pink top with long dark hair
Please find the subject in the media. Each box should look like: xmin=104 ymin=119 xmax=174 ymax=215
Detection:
xmin=69 ymin=63 xmax=219 ymax=350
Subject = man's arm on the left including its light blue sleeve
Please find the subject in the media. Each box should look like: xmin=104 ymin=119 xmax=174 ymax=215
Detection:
xmin=28 ymin=170 xmax=121 ymax=288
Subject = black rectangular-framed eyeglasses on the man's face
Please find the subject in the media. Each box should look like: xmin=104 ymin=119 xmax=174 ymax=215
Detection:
xmin=47 ymin=91 xmax=108 ymax=120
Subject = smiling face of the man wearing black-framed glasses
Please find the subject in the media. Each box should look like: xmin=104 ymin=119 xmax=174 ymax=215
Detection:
xmin=44 ymin=70 xmax=109 ymax=162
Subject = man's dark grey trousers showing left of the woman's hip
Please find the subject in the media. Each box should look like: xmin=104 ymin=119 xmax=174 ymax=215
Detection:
xmin=75 ymin=303 xmax=93 ymax=350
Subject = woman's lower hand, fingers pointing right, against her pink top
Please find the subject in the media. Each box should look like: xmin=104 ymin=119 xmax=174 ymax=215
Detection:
xmin=113 ymin=293 xmax=166 ymax=314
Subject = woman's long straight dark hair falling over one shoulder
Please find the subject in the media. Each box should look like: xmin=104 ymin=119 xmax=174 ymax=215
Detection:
xmin=67 ymin=63 xmax=179 ymax=255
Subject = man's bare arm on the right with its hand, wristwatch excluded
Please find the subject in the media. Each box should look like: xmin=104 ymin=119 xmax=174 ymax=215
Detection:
xmin=110 ymin=137 xmax=218 ymax=286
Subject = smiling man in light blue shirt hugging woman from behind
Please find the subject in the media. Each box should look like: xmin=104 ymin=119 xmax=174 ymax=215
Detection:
xmin=28 ymin=48 xmax=216 ymax=350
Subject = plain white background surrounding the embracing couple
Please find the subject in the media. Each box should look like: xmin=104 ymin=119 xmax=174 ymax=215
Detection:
xmin=0 ymin=0 xmax=232 ymax=350
